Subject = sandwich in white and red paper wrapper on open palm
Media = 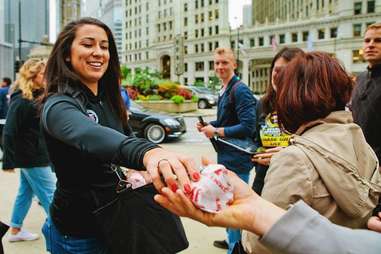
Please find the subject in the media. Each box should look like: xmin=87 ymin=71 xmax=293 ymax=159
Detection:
xmin=191 ymin=164 xmax=233 ymax=213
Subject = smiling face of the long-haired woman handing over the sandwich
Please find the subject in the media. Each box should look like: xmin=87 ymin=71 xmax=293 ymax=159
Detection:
xmin=70 ymin=25 xmax=110 ymax=87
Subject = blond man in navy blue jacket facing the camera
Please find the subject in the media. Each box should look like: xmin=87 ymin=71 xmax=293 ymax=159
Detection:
xmin=197 ymin=48 xmax=257 ymax=254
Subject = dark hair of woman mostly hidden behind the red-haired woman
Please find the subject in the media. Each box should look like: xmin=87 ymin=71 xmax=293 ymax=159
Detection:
xmin=262 ymin=47 xmax=303 ymax=115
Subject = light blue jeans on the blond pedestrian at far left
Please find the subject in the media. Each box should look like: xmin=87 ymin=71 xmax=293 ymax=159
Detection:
xmin=11 ymin=167 xmax=56 ymax=228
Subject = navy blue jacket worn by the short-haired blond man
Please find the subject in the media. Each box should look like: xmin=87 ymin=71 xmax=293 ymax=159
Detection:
xmin=210 ymin=76 xmax=257 ymax=174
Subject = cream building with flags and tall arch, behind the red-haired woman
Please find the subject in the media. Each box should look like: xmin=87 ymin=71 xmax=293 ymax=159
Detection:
xmin=240 ymin=0 xmax=381 ymax=93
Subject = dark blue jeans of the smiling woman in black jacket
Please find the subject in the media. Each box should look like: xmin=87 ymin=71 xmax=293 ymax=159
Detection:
xmin=42 ymin=218 xmax=108 ymax=254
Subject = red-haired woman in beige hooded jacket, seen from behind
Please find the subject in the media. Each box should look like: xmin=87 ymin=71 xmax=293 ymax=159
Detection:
xmin=242 ymin=52 xmax=381 ymax=253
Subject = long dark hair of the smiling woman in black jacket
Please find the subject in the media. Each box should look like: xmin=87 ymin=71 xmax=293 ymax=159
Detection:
xmin=41 ymin=18 xmax=127 ymax=127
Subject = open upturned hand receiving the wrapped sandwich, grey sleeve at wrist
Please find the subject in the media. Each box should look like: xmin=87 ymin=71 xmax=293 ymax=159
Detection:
xmin=155 ymin=159 xmax=285 ymax=235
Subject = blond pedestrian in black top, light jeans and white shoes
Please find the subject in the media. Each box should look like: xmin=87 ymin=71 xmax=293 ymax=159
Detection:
xmin=2 ymin=58 xmax=56 ymax=242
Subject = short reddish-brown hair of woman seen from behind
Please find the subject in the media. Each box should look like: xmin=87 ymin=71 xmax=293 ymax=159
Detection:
xmin=275 ymin=52 xmax=353 ymax=133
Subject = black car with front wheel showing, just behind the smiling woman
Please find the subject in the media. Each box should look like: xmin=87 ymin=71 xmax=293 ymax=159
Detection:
xmin=128 ymin=101 xmax=186 ymax=144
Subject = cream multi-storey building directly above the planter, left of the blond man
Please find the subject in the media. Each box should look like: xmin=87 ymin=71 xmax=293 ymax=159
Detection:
xmin=123 ymin=0 xmax=230 ymax=84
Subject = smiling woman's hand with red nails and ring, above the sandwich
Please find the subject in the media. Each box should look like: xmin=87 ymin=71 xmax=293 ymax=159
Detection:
xmin=143 ymin=148 xmax=200 ymax=193
